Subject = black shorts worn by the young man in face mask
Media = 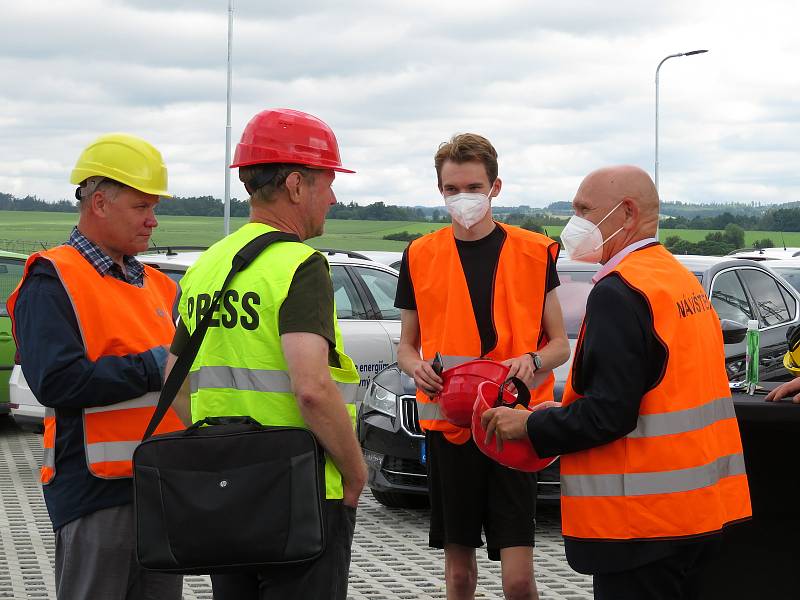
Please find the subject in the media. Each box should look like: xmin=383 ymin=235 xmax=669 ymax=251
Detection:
xmin=425 ymin=431 xmax=536 ymax=560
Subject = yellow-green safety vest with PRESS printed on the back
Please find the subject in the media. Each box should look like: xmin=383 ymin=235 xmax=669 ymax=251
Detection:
xmin=178 ymin=223 xmax=359 ymax=499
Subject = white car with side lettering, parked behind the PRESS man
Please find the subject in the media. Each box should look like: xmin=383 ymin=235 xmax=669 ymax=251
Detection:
xmin=9 ymin=250 xmax=400 ymax=425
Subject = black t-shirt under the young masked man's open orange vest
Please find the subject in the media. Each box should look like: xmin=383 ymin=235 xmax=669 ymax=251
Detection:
xmin=394 ymin=226 xmax=560 ymax=355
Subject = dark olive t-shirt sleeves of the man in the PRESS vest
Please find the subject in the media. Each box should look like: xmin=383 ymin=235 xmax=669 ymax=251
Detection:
xmin=170 ymin=252 xmax=340 ymax=368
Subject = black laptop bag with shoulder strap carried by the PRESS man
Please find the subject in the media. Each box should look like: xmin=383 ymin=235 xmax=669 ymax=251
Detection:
xmin=133 ymin=232 xmax=325 ymax=574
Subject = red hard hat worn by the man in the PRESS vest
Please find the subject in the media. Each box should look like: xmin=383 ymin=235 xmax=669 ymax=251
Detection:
xmin=231 ymin=108 xmax=355 ymax=173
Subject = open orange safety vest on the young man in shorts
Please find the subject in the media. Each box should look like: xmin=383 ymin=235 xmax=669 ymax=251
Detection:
xmin=408 ymin=223 xmax=558 ymax=444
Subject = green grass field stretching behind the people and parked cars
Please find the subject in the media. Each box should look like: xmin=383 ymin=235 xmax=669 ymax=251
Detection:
xmin=0 ymin=211 xmax=800 ymax=252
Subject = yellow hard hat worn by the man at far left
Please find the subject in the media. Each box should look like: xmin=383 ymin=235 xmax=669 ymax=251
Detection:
xmin=69 ymin=133 xmax=172 ymax=198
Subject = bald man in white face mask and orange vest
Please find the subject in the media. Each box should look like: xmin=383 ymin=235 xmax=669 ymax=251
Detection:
xmin=483 ymin=166 xmax=751 ymax=600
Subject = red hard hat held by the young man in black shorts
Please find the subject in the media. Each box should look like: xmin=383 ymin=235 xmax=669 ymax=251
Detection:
xmin=434 ymin=359 xmax=508 ymax=427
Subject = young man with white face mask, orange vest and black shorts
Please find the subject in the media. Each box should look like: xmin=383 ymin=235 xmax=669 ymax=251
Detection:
xmin=395 ymin=134 xmax=569 ymax=600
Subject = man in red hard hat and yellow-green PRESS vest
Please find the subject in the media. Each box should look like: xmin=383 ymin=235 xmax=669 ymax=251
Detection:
xmin=168 ymin=109 xmax=366 ymax=600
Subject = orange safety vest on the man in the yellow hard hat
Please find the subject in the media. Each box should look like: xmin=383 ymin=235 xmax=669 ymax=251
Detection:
xmin=8 ymin=246 xmax=184 ymax=484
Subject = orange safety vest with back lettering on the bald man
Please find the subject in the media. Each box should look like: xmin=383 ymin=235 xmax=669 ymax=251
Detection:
xmin=561 ymin=245 xmax=752 ymax=540
